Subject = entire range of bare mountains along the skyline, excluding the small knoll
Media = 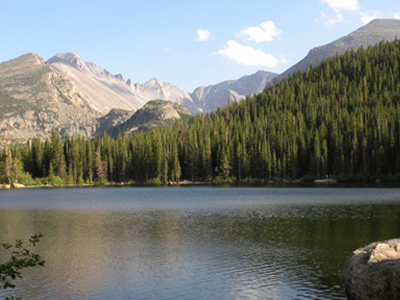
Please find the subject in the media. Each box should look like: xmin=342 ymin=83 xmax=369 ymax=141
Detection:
xmin=0 ymin=19 xmax=400 ymax=143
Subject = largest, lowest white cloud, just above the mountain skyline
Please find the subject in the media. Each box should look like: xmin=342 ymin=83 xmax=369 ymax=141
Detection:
xmin=217 ymin=40 xmax=279 ymax=67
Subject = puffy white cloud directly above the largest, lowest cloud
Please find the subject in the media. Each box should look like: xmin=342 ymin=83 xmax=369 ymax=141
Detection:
xmin=236 ymin=21 xmax=282 ymax=43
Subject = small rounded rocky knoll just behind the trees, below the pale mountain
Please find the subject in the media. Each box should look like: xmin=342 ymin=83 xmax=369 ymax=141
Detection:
xmin=108 ymin=100 xmax=192 ymax=137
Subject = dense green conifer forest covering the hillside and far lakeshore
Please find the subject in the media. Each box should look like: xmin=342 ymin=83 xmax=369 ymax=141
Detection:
xmin=3 ymin=40 xmax=400 ymax=183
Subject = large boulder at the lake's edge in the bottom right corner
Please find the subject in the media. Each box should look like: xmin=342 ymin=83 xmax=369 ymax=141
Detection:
xmin=342 ymin=239 xmax=400 ymax=300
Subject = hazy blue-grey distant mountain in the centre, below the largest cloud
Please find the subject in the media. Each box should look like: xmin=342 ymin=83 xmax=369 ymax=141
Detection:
xmin=191 ymin=71 xmax=277 ymax=112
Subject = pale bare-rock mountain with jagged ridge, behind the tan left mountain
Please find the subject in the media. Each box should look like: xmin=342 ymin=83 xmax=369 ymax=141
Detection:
xmin=48 ymin=53 xmax=200 ymax=114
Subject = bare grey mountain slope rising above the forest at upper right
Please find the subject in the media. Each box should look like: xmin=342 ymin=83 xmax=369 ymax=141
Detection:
xmin=275 ymin=19 xmax=400 ymax=82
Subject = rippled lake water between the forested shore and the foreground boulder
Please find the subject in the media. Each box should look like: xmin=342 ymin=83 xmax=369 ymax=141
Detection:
xmin=0 ymin=187 xmax=400 ymax=300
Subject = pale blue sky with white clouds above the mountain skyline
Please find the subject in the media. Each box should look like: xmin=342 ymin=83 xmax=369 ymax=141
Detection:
xmin=0 ymin=0 xmax=400 ymax=92
